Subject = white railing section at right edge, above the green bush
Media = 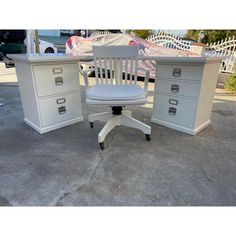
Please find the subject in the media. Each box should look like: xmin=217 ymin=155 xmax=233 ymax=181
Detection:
xmin=205 ymin=36 xmax=236 ymax=73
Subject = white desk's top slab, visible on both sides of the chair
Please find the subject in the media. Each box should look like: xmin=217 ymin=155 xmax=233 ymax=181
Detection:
xmin=7 ymin=53 xmax=223 ymax=63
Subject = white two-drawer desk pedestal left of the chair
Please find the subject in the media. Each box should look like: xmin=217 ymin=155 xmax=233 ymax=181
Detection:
xmin=11 ymin=54 xmax=83 ymax=134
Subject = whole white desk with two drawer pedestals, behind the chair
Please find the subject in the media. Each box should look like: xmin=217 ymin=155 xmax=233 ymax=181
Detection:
xmin=9 ymin=54 xmax=222 ymax=135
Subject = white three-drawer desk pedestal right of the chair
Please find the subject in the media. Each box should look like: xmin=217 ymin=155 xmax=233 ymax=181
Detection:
xmin=151 ymin=57 xmax=222 ymax=135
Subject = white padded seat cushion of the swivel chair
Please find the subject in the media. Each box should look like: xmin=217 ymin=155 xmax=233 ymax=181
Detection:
xmin=87 ymin=84 xmax=146 ymax=101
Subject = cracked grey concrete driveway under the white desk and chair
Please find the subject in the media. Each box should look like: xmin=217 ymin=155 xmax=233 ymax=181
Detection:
xmin=0 ymin=63 xmax=236 ymax=206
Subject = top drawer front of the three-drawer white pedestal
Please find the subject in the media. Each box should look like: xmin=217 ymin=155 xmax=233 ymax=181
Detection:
xmin=157 ymin=65 xmax=202 ymax=81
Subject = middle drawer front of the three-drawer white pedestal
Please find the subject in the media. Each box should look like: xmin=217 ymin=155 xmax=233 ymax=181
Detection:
xmin=157 ymin=78 xmax=200 ymax=97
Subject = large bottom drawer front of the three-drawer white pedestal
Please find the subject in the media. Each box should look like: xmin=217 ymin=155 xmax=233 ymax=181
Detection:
xmin=153 ymin=94 xmax=197 ymax=128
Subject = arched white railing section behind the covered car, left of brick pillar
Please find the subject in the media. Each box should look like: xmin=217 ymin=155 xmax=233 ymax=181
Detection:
xmin=146 ymin=32 xmax=191 ymax=51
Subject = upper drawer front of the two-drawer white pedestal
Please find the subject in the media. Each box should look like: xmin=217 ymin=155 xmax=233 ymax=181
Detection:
xmin=33 ymin=64 xmax=79 ymax=97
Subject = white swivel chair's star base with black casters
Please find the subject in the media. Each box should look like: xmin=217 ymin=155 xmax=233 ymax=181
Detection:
xmin=89 ymin=106 xmax=151 ymax=150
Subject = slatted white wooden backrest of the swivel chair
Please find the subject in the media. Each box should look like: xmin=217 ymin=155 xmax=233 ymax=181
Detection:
xmin=93 ymin=45 xmax=139 ymax=85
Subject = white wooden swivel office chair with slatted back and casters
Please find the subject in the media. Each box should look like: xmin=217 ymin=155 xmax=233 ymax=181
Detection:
xmin=83 ymin=46 xmax=151 ymax=150
